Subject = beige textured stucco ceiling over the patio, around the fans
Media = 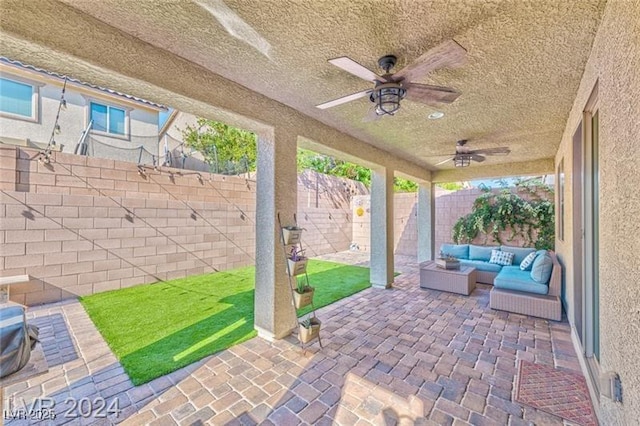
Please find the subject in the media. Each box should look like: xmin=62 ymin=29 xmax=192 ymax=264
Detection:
xmin=8 ymin=0 xmax=604 ymax=170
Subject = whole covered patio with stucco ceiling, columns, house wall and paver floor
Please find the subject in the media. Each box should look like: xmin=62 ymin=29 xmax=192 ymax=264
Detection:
xmin=0 ymin=0 xmax=640 ymax=425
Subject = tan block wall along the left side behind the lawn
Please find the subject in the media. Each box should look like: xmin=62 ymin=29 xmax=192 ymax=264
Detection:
xmin=0 ymin=145 xmax=364 ymax=305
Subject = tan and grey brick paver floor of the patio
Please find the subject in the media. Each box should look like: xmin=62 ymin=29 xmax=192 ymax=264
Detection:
xmin=5 ymin=253 xmax=579 ymax=425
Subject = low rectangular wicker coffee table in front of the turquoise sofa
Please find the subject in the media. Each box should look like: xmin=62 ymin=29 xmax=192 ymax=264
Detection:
xmin=420 ymin=260 xmax=476 ymax=296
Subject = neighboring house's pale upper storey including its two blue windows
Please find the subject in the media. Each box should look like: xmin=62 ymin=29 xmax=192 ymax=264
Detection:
xmin=0 ymin=57 xmax=167 ymax=164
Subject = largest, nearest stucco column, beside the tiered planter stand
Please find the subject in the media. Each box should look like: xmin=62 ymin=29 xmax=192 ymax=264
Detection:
xmin=254 ymin=131 xmax=304 ymax=340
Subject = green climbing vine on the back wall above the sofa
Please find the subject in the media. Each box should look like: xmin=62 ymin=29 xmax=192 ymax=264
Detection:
xmin=453 ymin=182 xmax=555 ymax=250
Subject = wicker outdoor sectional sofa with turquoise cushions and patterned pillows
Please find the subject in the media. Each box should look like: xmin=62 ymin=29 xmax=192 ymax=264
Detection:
xmin=440 ymin=244 xmax=562 ymax=321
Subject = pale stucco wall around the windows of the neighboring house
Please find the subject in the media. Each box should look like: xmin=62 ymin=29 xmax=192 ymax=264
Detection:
xmin=0 ymin=71 xmax=158 ymax=160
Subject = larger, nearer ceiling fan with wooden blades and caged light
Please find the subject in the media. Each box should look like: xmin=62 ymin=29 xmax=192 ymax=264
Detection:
xmin=316 ymin=40 xmax=467 ymax=119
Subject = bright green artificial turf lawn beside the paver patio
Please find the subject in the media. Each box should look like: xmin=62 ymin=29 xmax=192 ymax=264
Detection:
xmin=80 ymin=260 xmax=371 ymax=385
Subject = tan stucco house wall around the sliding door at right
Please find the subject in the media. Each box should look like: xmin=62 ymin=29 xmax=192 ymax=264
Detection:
xmin=556 ymin=1 xmax=640 ymax=425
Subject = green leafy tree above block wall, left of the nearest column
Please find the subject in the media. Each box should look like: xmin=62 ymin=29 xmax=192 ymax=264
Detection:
xmin=182 ymin=118 xmax=256 ymax=172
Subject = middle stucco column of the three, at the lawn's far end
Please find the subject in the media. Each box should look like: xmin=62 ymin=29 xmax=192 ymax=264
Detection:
xmin=370 ymin=168 xmax=394 ymax=288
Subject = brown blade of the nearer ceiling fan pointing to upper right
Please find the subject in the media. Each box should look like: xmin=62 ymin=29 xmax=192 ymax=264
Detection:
xmin=393 ymin=40 xmax=467 ymax=81
